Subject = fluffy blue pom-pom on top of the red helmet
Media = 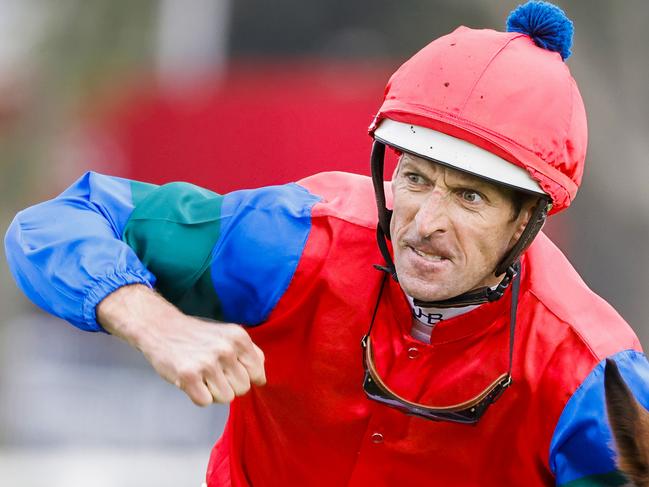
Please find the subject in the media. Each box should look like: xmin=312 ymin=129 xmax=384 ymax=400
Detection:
xmin=507 ymin=1 xmax=574 ymax=61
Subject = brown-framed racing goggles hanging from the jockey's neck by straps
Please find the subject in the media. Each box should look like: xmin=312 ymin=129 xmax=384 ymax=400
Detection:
xmin=361 ymin=265 xmax=520 ymax=424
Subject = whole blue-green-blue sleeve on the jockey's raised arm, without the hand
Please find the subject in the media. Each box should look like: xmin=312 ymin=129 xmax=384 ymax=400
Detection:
xmin=5 ymin=172 xmax=319 ymax=331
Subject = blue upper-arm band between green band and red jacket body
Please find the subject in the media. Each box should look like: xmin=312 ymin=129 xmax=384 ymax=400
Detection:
xmin=210 ymin=183 xmax=320 ymax=325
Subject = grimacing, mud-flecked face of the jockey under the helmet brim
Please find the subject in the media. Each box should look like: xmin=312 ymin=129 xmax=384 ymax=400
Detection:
xmin=390 ymin=154 xmax=533 ymax=301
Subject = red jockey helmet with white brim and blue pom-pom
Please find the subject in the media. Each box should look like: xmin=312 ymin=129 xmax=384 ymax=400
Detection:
xmin=369 ymin=2 xmax=588 ymax=212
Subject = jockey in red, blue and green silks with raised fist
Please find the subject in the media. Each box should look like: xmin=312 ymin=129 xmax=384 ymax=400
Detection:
xmin=5 ymin=2 xmax=649 ymax=486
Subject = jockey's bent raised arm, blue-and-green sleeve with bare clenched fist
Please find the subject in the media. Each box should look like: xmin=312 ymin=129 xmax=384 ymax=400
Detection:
xmin=5 ymin=173 xmax=317 ymax=404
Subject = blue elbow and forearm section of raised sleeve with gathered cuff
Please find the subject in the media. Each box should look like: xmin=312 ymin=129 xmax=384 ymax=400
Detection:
xmin=5 ymin=172 xmax=156 ymax=331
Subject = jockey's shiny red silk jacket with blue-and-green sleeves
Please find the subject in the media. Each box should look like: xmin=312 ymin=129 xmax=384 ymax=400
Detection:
xmin=5 ymin=173 xmax=649 ymax=486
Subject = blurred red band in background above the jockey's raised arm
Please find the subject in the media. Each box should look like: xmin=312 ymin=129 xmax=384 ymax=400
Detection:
xmin=105 ymin=60 xmax=394 ymax=192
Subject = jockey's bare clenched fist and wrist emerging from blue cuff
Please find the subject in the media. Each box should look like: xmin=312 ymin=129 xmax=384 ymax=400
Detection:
xmin=97 ymin=284 xmax=266 ymax=406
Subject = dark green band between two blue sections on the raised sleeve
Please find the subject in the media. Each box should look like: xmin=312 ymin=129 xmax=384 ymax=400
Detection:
xmin=122 ymin=183 xmax=223 ymax=319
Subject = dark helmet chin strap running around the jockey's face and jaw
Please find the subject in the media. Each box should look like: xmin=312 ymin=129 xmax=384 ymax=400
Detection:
xmin=371 ymin=141 xmax=552 ymax=308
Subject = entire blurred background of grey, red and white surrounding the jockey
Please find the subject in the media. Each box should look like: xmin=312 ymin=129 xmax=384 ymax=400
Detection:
xmin=0 ymin=0 xmax=649 ymax=487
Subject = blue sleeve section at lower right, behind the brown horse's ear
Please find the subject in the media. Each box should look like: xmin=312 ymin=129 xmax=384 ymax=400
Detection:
xmin=550 ymin=350 xmax=649 ymax=487
